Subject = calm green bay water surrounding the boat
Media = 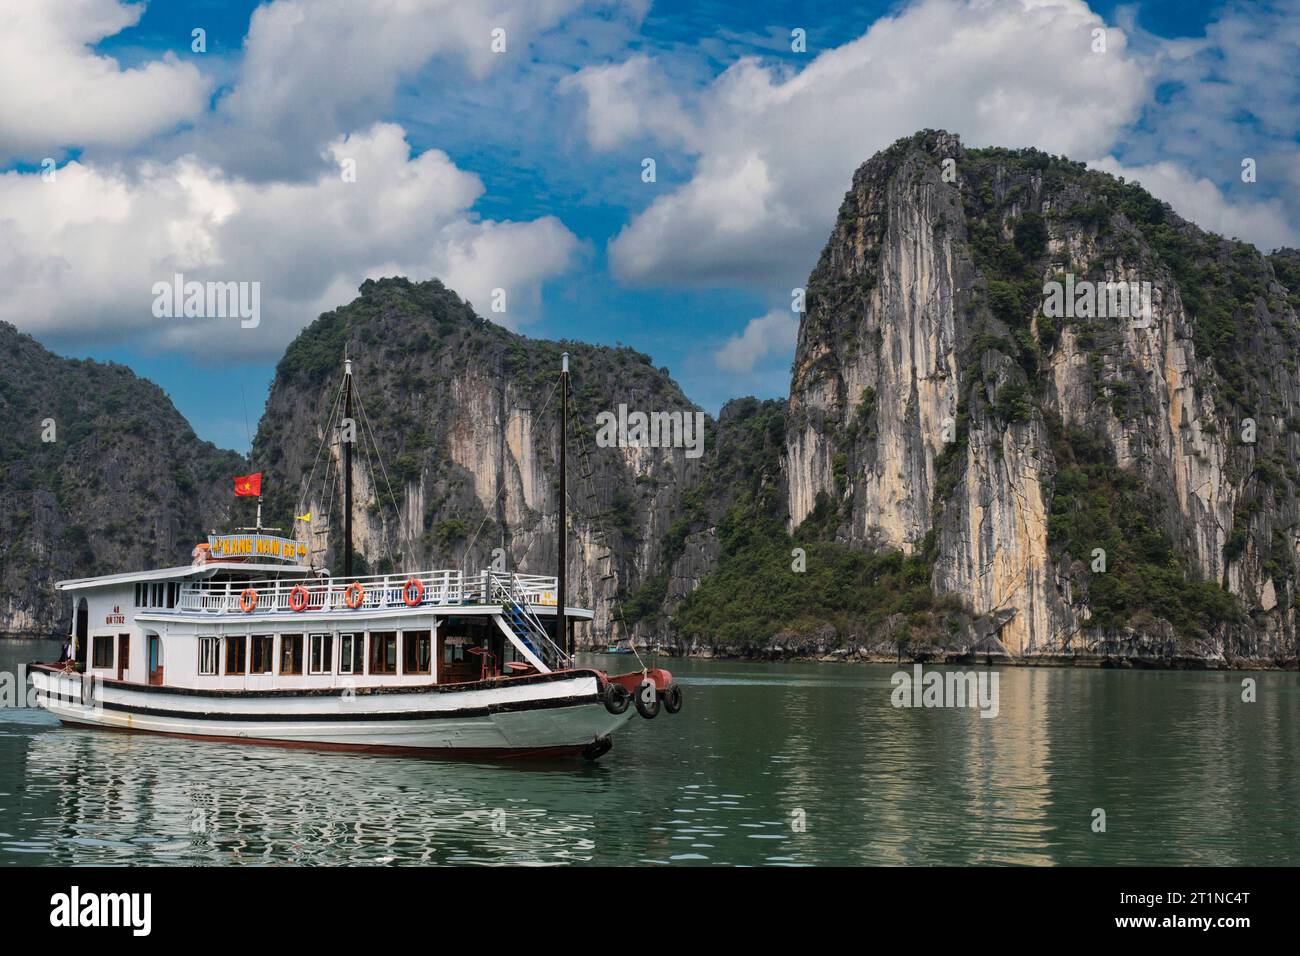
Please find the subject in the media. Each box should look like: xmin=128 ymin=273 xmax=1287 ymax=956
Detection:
xmin=0 ymin=641 xmax=1300 ymax=865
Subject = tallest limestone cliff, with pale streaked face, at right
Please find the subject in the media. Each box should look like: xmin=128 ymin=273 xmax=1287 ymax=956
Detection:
xmin=785 ymin=133 xmax=1300 ymax=657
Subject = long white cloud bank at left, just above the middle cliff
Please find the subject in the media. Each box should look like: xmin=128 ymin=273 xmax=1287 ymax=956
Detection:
xmin=0 ymin=124 xmax=579 ymax=360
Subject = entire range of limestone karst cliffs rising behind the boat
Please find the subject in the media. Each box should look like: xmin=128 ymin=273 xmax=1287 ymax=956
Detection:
xmin=0 ymin=131 xmax=1300 ymax=661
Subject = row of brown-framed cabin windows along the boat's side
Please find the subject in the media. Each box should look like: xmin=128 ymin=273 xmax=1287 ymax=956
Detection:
xmin=199 ymin=631 xmax=434 ymax=676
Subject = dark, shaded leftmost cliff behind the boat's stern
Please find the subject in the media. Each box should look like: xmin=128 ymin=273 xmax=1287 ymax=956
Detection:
xmin=0 ymin=323 xmax=246 ymax=633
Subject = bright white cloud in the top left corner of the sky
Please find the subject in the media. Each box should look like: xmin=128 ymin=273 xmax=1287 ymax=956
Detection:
xmin=0 ymin=0 xmax=208 ymax=163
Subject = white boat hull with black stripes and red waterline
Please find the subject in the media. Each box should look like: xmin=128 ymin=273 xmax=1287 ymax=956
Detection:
xmin=31 ymin=670 xmax=636 ymax=757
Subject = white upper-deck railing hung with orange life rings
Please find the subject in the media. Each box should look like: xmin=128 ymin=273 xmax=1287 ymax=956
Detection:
xmin=177 ymin=570 xmax=558 ymax=614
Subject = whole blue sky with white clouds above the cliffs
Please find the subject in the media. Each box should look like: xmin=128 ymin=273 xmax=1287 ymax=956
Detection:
xmin=0 ymin=0 xmax=1300 ymax=450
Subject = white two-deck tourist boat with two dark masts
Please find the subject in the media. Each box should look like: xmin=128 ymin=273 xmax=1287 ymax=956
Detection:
xmin=31 ymin=355 xmax=681 ymax=760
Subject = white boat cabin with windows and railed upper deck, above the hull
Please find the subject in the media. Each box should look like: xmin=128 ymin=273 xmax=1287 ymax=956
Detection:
xmin=57 ymin=561 xmax=592 ymax=692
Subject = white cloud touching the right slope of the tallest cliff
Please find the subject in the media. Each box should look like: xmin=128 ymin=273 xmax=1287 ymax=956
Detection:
xmin=1089 ymin=156 xmax=1300 ymax=251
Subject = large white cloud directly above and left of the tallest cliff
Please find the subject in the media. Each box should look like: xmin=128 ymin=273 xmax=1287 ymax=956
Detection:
xmin=589 ymin=0 xmax=1149 ymax=287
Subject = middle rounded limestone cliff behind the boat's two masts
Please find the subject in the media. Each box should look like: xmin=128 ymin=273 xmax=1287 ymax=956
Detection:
xmin=246 ymin=278 xmax=712 ymax=647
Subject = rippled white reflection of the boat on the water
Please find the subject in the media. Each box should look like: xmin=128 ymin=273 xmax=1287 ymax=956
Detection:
xmin=7 ymin=728 xmax=619 ymax=865
